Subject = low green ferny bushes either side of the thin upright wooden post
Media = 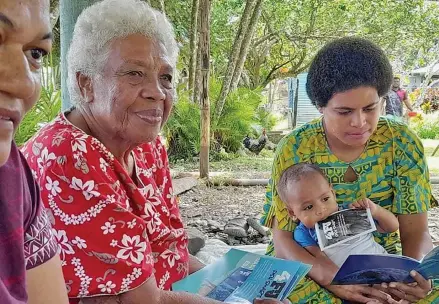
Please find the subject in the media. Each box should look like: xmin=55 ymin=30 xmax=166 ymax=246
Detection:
xmin=164 ymin=77 xmax=275 ymax=161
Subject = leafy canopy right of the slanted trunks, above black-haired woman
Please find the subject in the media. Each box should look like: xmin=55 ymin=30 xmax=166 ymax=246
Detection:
xmin=246 ymin=0 xmax=439 ymax=86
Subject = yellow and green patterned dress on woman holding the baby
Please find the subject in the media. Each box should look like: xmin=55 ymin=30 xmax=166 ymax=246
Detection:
xmin=261 ymin=117 xmax=439 ymax=304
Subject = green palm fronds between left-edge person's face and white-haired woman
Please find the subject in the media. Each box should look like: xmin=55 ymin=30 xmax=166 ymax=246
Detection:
xmin=15 ymin=55 xmax=61 ymax=146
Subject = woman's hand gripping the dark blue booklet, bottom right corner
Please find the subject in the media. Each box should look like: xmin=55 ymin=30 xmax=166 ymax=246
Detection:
xmin=383 ymin=270 xmax=432 ymax=303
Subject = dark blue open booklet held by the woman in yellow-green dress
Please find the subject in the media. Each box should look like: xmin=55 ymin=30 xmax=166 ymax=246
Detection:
xmin=331 ymin=247 xmax=439 ymax=285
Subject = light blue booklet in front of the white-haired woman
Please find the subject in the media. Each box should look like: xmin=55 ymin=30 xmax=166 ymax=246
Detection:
xmin=172 ymin=249 xmax=311 ymax=304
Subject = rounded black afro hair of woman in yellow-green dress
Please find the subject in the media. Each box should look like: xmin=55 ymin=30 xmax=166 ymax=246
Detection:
xmin=306 ymin=37 xmax=393 ymax=107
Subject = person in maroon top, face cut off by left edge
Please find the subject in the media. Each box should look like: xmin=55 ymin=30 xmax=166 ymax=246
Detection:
xmin=0 ymin=0 xmax=68 ymax=304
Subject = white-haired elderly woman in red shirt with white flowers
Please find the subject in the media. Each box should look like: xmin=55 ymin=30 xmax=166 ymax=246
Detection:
xmin=23 ymin=0 xmax=286 ymax=304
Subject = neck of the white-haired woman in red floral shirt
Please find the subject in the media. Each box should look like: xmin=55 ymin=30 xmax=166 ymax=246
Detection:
xmin=66 ymin=109 xmax=136 ymax=175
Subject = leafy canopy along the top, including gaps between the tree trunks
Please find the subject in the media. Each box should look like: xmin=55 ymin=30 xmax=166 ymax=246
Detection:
xmin=166 ymin=0 xmax=439 ymax=88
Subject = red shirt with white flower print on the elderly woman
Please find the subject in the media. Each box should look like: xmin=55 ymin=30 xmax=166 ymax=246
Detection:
xmin=23 ymin=114 xmax=189 ymax=303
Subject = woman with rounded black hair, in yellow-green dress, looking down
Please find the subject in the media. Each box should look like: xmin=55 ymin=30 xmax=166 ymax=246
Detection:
xmin=262 ymin=38 xmax=439 ymax=303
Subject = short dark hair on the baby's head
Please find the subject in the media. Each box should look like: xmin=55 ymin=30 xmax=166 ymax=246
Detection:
xmin=277 ymin=163 xmax=329 ymax=202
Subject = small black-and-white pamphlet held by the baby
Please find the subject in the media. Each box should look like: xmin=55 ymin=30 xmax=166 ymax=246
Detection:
xmin=315 ymin=209 xmax=376 ymax=251
